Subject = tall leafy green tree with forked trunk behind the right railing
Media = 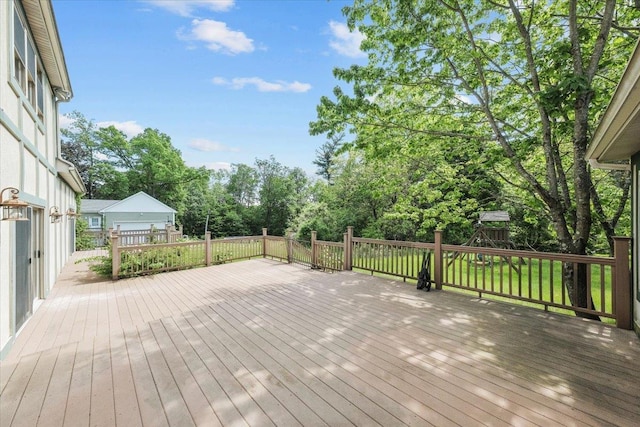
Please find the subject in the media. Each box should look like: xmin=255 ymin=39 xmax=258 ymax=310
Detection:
xmin=311 ymin=0 xmax=638 ymax=318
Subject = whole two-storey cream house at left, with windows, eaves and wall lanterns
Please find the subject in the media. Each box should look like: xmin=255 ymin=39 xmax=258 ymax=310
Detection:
xmin=0 ymin=0 xmax=85 ymax=359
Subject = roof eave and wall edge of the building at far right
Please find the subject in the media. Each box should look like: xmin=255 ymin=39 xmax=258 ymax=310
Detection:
xmin=587 ymin=39 xmax=640 ymax=335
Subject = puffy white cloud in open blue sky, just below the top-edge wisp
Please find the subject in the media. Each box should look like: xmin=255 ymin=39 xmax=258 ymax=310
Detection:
xmin=178 ymin=19 xmax=255 ymax=55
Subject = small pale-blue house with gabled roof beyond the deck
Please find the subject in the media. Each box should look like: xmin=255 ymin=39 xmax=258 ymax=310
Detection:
xmin=81 ymin=191 xmax=177 ymax=242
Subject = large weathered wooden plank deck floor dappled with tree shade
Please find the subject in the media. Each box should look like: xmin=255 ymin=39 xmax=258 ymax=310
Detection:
xmin=0 ymin=252 xmax=640 ymax=427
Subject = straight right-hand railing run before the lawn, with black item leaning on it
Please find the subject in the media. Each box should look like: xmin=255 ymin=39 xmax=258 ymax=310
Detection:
xmin=345 ymin=229 xmax=632 ymax=329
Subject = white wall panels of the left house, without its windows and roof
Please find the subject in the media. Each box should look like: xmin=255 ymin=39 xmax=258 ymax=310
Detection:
xmin=0 ymin=0 xmax=76 ymax=359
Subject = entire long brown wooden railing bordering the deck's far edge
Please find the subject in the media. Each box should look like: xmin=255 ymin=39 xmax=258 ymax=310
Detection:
xmin=111 ymin=227 xmax=632 ymax=329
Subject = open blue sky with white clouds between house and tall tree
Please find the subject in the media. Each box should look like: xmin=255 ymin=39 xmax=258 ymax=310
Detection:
xmin=53 ymin=0 xmax=364 ymax=175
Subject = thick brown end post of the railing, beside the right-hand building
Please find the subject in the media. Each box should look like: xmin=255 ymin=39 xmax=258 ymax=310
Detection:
xmin=613 ymin=237 xmax=633 ymax=329
